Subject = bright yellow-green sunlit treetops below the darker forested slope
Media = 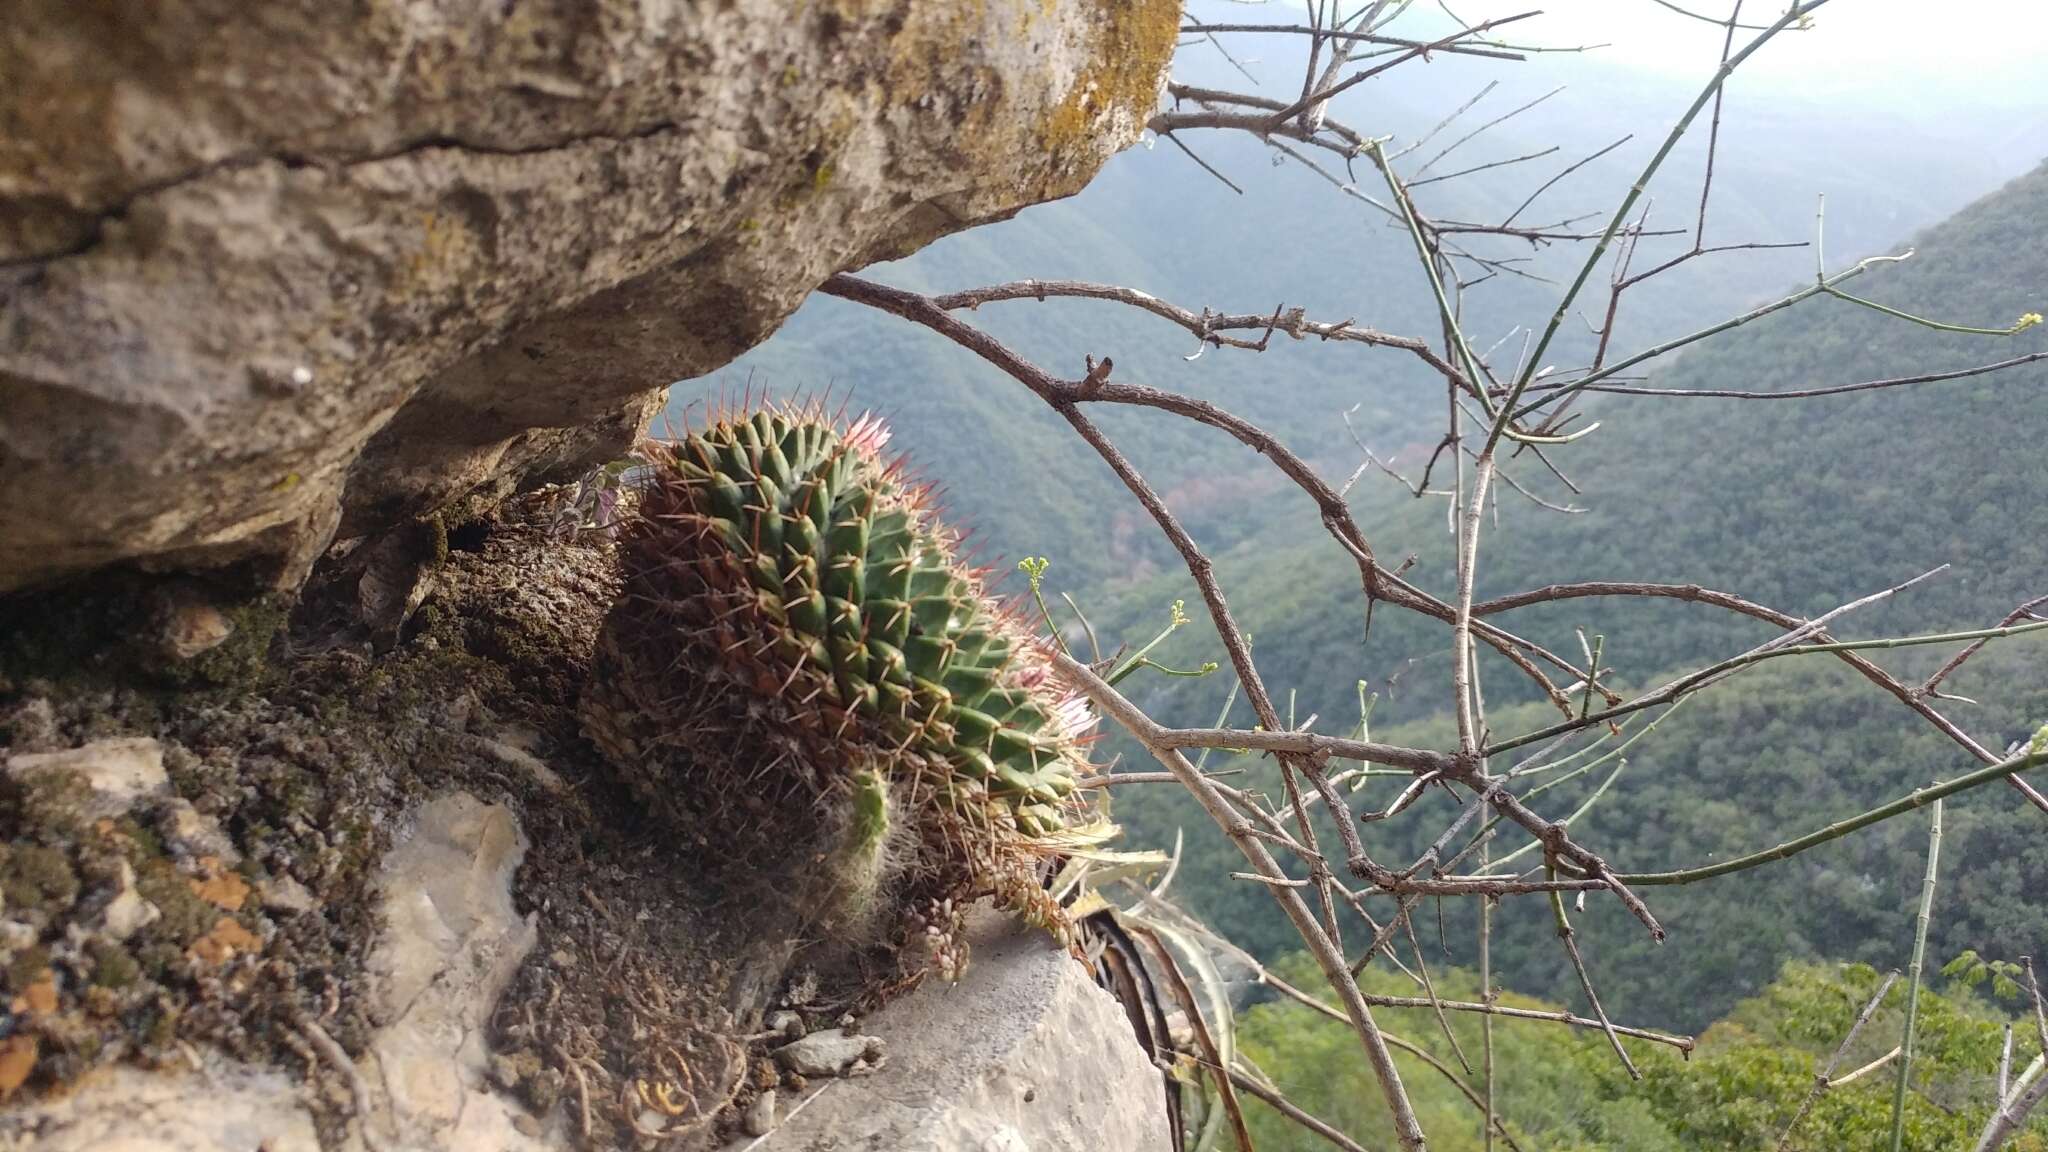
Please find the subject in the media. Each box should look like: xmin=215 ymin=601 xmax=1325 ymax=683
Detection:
xmin=1239 ymin=963 xmax=2048 ymax=1152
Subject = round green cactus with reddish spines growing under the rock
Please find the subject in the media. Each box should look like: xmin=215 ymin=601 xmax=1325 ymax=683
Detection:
xmin=584 ymin=404 xmax=1090 ymax=947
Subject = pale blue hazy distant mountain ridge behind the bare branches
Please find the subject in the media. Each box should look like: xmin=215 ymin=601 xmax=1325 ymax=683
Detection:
xmin=672 ymin=37 xmax=2009 ymax=588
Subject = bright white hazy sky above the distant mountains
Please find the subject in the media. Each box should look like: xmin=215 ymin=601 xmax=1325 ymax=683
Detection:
xmin=1261 ymin=0 xmax=2048 ymax=91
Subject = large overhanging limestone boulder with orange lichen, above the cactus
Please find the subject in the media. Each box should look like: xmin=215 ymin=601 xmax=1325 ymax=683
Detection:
xmin=0 ymin=0 xmax=1180 ymax=590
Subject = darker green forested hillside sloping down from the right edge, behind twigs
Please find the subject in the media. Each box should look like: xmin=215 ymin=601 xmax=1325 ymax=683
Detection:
xmin=1098 ymin=156 xmax=2048 ymax=1027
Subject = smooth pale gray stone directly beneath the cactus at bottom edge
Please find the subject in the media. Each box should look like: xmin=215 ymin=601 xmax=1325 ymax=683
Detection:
xmin=758 ymin=912 xmax=1171 ymax=1152
